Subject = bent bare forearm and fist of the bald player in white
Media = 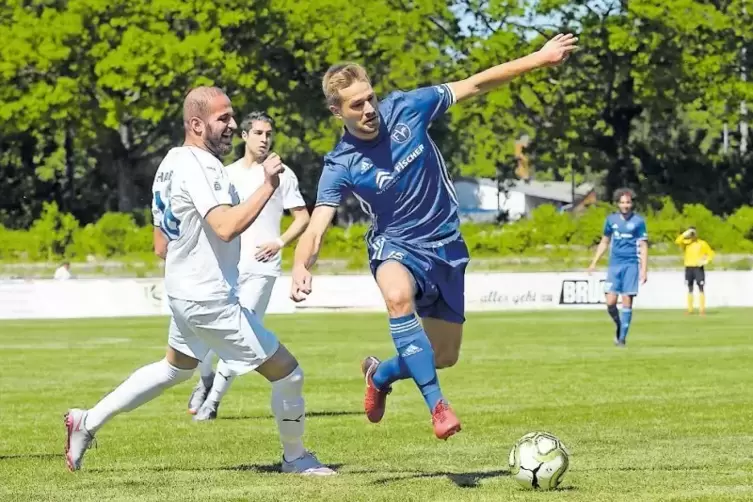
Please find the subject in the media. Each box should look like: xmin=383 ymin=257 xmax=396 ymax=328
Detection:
xmin=205 ymin=153 xmax=284 ymax=242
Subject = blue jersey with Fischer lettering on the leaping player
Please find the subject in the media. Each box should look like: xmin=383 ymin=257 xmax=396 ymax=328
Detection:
xmin=316 ymin=84 xmax=460 ymax=247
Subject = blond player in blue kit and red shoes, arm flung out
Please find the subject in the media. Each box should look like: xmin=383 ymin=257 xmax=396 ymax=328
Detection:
xmin=291 ymin=34 xmax=577 ymax=439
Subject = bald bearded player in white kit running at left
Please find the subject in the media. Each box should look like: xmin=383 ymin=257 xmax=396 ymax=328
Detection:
xmin=65 ymin=87 xmax=335 ymax=475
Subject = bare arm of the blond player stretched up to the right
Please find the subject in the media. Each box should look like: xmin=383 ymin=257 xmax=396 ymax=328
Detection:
xmin=448 ymin=33 xmax=578 ymax=102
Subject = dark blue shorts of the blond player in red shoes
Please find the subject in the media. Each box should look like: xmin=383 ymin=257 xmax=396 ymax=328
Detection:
xmin=369 ymin=237 xmax=469 ymax=324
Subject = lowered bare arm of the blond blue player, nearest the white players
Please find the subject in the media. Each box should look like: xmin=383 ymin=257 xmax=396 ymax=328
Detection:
xmin=290 ymin=206 xmax=337 ymax=302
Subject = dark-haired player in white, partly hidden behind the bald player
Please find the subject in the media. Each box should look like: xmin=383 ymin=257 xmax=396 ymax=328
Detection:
xmin=188 ymin=111 xmax=309 ymax=421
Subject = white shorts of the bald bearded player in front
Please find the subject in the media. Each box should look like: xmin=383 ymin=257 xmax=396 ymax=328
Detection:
xmin=167 ymin=297 xmax=280 ymax=375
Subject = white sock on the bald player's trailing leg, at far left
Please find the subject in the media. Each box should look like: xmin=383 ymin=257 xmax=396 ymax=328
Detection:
xmin=84 ymin=359 xmax=193 ymax=435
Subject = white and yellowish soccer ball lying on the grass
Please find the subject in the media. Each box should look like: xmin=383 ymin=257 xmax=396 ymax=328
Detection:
xmin=510 ymin=432 xmax=570 ymax=490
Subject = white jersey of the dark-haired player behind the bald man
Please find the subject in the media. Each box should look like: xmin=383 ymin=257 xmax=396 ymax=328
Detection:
xmin=227 ymin=159 xmax=306 ymax=281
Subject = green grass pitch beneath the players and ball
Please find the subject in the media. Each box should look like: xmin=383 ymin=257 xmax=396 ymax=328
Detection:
xmin=0 ymin=309 xmax=753 ymax=502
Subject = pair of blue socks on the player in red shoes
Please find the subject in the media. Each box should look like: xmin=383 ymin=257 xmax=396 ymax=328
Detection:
xmin=372 ymin=314 xmax=443 ymax=411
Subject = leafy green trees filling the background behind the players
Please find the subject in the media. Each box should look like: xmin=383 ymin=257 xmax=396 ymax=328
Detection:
xmin=0 ymin=0 xmax=753 ymax=228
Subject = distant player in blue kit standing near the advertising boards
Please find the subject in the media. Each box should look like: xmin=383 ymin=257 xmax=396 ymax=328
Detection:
xmin=588 ymin=188 xmax=648 ymax=347
